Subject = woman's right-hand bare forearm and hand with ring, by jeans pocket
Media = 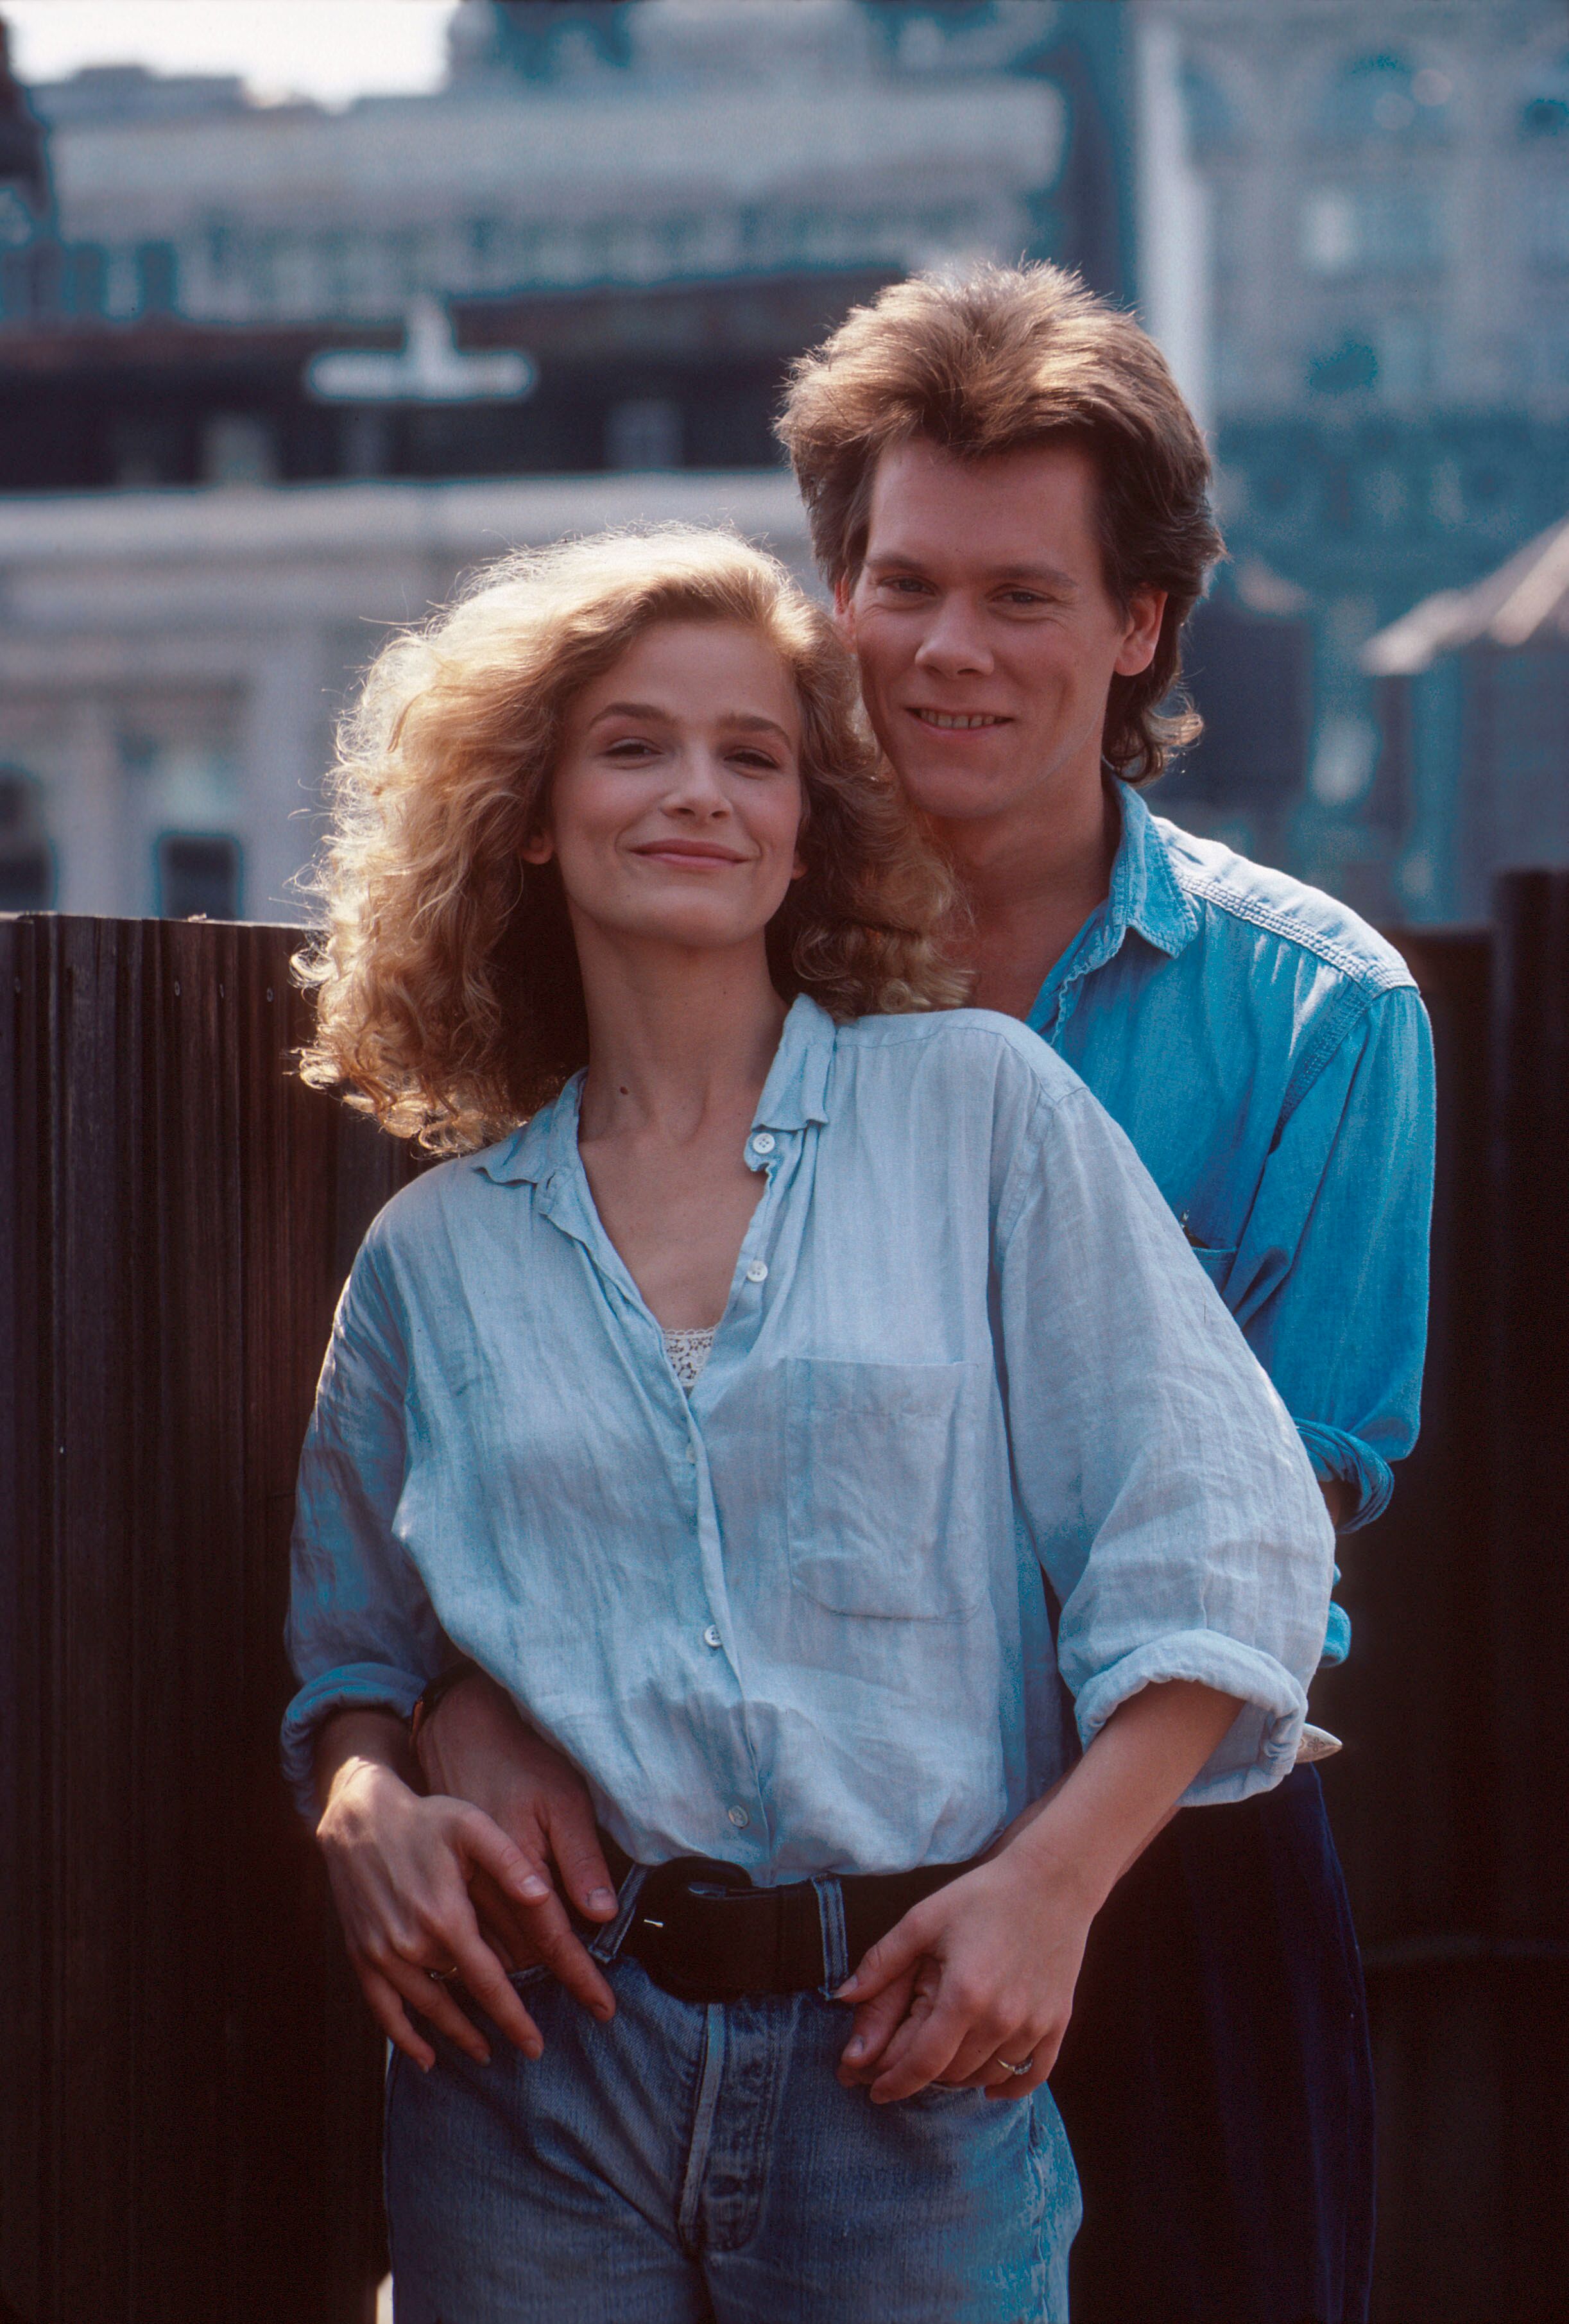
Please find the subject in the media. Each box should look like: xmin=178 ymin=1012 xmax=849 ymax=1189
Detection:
xmin=839 ymin=1680 xmax=1239 ymax=2106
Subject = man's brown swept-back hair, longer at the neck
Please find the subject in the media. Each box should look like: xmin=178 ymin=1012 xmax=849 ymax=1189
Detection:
xmin=778 ymin=265 xmax=1222 ymax=783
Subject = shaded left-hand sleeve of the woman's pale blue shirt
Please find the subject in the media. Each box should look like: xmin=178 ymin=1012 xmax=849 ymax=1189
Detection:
xmin=284 ymin=1230 xmax=446 ymax=1820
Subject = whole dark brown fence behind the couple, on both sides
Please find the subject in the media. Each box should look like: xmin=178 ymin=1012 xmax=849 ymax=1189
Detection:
xmin=0 ymin=874 xmax=1569 ymax=2324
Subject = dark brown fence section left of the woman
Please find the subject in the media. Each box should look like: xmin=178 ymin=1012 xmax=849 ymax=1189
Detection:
xmin=0 ymin=918 xmax=404 ymax=2324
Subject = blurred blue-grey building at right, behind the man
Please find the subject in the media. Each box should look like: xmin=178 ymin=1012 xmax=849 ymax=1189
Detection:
xmin=1142 ymin=0 xmax=1569 ymax=923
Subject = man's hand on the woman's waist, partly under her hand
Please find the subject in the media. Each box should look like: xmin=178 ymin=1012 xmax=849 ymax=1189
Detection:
xmin=416 ymin=1671 xmax=616 ymax=2017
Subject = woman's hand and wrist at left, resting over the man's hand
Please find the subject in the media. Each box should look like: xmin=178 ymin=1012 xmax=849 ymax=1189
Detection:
xmin=316 ymin=1713 xmax=583 ymax=2069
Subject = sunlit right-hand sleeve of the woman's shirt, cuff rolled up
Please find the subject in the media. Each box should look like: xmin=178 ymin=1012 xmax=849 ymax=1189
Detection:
xmin=997 ymin=1090 xmax=1334 ymax=1803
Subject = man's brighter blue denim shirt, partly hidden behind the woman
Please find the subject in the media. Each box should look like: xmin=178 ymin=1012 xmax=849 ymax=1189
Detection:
xmin=1030 ymin=783 xmax=1434 ymax=1662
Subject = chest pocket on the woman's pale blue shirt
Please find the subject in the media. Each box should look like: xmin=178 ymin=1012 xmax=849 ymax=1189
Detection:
xmin=785 ymin=1357 xmax=988 ymax=1622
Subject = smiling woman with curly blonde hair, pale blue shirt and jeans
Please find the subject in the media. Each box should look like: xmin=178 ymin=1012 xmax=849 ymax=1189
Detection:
xmin=286 ymin=532 xmax=1332 ymax=2324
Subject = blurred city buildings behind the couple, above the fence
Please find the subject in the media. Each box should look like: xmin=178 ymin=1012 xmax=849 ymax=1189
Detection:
xmin=0 ymin=0 xmax=1569 ymax=925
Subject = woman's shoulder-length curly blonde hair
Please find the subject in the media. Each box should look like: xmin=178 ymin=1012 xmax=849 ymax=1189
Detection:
xmin=295 ymin=525 xmax=967 ymax=1153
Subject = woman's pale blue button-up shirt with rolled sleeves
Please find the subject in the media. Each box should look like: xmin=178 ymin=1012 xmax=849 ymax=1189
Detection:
xmin=284 ymin=999 xmax=1332 ymax=1882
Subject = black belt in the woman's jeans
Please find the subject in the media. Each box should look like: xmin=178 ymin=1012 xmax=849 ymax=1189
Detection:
xmin=600 ymin=1834 xmax=979 ymax=2001
